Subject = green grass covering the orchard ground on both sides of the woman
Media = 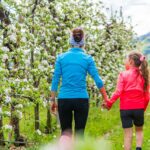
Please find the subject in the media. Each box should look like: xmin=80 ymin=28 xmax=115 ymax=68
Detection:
xmin=0 ymin=103 xmax=150 ymax=150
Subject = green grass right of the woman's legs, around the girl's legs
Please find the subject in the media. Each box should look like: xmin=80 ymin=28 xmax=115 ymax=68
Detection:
xmin=86 ymin=104 xmax=150 ymax=150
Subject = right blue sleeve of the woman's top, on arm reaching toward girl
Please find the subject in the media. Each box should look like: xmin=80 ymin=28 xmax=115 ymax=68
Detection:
xmin=88 ymin=56 xmax=104 ymax=89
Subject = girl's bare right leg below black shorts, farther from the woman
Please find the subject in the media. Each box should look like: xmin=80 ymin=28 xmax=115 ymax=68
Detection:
xmin=135 ymin=126 xmax=143 ymax=150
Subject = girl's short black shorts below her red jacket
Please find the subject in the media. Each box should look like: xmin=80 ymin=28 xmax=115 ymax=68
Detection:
xmin=120 ymin=109 xmax=144 ymax=128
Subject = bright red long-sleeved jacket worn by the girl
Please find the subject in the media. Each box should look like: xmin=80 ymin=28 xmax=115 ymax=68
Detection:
xmin=107 ymin=67 xmax=149 ymax=110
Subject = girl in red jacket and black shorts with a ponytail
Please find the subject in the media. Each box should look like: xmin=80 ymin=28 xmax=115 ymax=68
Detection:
xmin=106 ymin=52 xmax=149 ymax=150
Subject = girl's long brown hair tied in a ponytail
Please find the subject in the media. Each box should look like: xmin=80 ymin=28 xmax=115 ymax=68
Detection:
xmin=129 ymin=52 xmax=149 ymax=91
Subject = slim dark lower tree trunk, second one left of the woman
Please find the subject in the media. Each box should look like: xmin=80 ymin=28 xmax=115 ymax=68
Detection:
xmin=34 ymin=103 xmax=40 ymax=130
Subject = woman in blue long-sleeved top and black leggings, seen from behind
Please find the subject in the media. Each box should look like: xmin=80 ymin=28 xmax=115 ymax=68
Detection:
xmin=51 ymin=28 xmax=107 ymax=135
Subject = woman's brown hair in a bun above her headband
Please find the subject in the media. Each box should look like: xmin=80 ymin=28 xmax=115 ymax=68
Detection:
xmin=72 ymin=28 xmax=84 ymax=42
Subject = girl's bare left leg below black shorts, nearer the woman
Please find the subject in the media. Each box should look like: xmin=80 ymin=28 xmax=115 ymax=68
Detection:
xmin=124 ymin=128 xmax=133 ymax=150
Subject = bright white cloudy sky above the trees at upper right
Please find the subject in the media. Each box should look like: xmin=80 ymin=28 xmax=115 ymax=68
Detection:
xmin=98 ymin=0 xmax=150 ymax=35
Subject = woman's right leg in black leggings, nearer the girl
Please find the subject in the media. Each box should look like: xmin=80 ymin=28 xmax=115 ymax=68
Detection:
xmin=74 ymin=99 xmax=89 ymax=137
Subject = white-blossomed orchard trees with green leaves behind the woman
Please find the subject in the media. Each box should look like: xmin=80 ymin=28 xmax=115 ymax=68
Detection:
xmin=0 ymin=0 xmax=133 ymax=146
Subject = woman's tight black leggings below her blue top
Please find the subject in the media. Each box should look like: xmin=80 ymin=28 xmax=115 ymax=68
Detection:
xmin=58 ymin=98 xmax=89 ymax=135
